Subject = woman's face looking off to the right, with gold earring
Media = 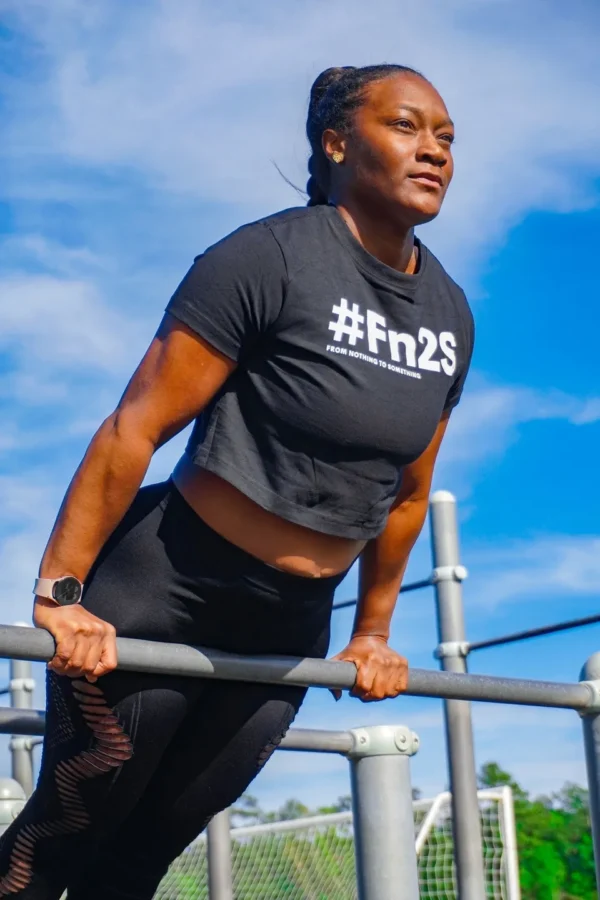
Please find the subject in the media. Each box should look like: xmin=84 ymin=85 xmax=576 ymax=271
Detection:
xmin=325 ymin=74 xmax=454 ymax=227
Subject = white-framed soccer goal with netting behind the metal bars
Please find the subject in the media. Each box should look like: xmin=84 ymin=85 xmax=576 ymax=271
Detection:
xmin=156 ymin=788 xmax=519 ymax=900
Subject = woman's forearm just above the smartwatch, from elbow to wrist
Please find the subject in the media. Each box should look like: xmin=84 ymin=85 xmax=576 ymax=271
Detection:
xmin=40 ymin=413 xmax=155 ymax=581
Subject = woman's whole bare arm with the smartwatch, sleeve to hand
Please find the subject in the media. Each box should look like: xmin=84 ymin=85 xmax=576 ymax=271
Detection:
xmin=34 ymin=315 xmax=235 ymax=678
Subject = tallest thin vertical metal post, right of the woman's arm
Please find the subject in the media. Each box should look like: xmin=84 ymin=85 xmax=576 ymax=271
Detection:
xmin=430 ymin=491 xmax=486 ymax=900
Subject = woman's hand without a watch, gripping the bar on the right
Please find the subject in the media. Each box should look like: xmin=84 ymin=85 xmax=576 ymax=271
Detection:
xmin=332 ymin=635 xmax=408 ymax=703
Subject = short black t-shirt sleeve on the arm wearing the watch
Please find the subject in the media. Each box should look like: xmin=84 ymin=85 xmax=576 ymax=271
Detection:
xmin=166 ymin=223 xmax=287 ymax=362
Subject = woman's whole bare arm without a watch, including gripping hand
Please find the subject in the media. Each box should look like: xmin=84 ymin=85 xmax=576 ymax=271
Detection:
xmin=335 ymin=414 xmax=449 ymax=701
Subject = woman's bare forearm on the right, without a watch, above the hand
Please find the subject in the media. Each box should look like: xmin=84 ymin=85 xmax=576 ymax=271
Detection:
xmin=352 ymin=499 xmax=427 ymax=640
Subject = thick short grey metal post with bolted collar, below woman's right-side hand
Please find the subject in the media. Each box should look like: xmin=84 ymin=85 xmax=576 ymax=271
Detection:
xmin=348 ymin=725 xmax=419 ymax=900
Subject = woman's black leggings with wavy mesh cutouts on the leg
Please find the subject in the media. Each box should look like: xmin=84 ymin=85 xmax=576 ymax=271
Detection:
xmin=0 ymin=482 xmax=343 ymax=900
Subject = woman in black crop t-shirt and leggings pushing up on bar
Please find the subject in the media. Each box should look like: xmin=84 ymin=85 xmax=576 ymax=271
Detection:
xmin=0 ymin=65 xmax=473 ymax=900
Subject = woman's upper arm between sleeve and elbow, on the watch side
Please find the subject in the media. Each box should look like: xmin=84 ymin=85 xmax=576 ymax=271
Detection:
xmin=115 ymin=313 xmax=236 ymax=448
